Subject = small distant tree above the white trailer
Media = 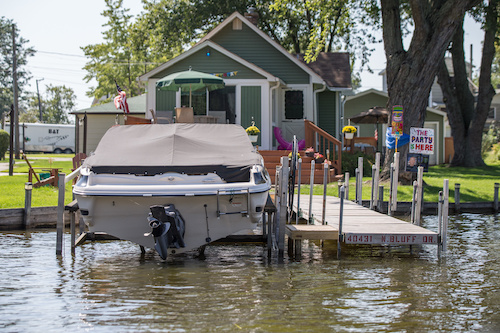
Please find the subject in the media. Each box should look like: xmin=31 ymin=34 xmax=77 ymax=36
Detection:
xmin=43 ymin=84 xmax=76 ymax=124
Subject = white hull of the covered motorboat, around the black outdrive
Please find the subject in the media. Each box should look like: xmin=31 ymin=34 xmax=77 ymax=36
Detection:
xmin=76 ymin=185 xmax=268 ymax=254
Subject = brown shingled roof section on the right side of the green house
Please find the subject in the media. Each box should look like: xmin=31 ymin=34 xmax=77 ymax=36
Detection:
xmin=298 ymin=52 xmax=352 ymax=89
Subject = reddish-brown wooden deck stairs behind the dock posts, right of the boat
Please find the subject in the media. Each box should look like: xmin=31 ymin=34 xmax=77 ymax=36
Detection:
xmin=259 ymin=150 xmax=342 ymax=184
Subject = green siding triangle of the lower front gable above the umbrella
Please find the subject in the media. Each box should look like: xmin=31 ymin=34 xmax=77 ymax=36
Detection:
xmin=150 ymin=47 xmax=264 ymax=79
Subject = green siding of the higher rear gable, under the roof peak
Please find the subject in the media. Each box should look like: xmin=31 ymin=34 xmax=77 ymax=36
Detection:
xmin=212 ymin=24 xmax=309 ymax=84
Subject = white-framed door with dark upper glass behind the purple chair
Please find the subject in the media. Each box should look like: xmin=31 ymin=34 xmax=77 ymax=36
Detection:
xmin=281 ymin=90 xmax=305 ymax=142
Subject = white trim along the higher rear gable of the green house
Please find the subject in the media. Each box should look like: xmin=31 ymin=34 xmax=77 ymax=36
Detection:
xmin=196 ymin=12 xmax=323 ymax=83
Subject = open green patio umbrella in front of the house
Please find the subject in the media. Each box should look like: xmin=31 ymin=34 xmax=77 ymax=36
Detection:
xmin=156 ymin=69 xmax=225 ymax=107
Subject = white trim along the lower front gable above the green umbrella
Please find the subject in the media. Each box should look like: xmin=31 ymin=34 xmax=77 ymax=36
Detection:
xmin=138 ymin=40 xmax=277 ymax=81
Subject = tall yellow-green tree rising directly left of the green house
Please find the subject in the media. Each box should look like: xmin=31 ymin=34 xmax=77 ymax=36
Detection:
xmin=82 ymin=0 xmax=144 ymax=99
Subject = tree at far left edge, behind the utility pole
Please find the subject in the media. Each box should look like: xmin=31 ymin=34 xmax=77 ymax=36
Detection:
xmin=0 ymin=16 xmax=35 ymax=117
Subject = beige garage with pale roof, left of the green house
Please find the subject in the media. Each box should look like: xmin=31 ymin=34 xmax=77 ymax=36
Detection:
xmin=71 ymin=94 xmax=146 ymax=155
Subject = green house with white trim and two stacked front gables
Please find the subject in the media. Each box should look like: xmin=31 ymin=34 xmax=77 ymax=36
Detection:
xmin=139 ymin=12 xmax=351 ymax=149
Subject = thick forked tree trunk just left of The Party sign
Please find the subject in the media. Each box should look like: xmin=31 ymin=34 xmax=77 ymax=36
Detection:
xmin=381 ymin=0 xmax=479 ymax=183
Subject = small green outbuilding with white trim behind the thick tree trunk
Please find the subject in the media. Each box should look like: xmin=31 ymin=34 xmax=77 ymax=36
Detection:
xmin=344 ymin=89 xmax=447 ymax=165
